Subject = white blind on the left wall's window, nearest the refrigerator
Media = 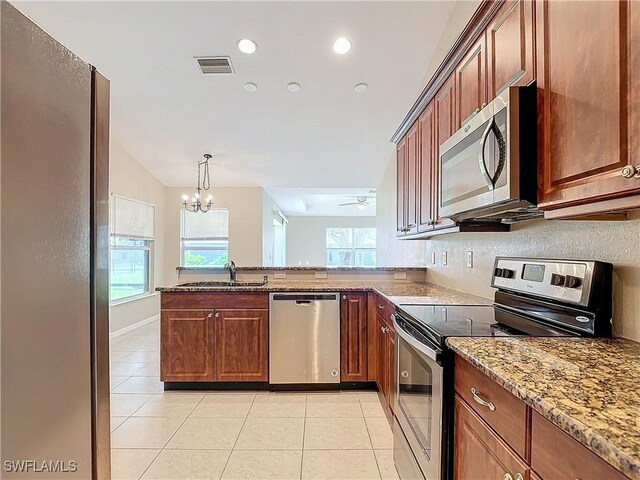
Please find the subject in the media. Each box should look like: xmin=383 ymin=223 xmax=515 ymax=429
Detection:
xmin=111 ymin=195 xmax=155 ymax=240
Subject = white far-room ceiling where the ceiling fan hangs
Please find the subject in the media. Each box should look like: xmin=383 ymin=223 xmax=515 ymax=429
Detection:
xmin=266 ymin=188 xmax=376 ymax=217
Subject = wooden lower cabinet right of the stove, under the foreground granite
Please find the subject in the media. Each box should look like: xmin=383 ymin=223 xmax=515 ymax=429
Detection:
xmin=453 ymin=356 xmax=628 ymax=480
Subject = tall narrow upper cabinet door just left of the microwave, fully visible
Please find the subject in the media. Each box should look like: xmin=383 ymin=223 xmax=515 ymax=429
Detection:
xmin=418 ymin=103 xmax=438 ymax=232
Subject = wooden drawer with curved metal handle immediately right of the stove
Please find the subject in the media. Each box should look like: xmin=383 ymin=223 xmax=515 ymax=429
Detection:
xmin=454 ymin=356 xmax=528 ymax=458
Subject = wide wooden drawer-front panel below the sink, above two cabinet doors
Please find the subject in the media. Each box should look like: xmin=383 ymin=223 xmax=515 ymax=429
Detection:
xmin=161 ymin=292 xmax=269 ymax=309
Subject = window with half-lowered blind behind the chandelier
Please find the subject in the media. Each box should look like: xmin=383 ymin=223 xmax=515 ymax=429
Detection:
xmin=180 ymin=208 xmax=229 ymax=267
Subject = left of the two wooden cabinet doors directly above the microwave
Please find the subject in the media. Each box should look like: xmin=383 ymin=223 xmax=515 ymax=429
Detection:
xmin=458 ymin=35 xmax=487 ymax=126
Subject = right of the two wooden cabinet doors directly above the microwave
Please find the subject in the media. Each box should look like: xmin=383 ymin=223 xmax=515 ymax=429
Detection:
xmin=487 ymin=0 xmax=535 ymax=100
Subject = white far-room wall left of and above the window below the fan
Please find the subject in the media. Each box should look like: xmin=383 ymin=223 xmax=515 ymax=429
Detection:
xmin=287 ymin=217 xmax=376 ymax=267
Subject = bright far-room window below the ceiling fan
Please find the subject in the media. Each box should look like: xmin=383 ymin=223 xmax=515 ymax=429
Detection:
xmin=326 ymin=228 xmax=376 ymax=267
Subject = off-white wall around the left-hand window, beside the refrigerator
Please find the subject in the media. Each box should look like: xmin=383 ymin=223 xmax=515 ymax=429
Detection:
xmin=109 ymin=139 xmax=166 ymax=332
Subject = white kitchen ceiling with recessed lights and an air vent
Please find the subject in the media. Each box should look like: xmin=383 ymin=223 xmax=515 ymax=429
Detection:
xmin=13 ymin=1 xmax=454 ymax=193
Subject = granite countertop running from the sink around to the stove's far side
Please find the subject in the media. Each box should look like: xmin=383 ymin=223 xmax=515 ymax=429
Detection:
xmin=156 ymin=279 xmax=493 ymax=305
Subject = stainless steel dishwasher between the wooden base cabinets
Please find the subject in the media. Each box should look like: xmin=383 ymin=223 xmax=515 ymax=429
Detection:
xmin=269 ymin=292 xmax=340 ymax=384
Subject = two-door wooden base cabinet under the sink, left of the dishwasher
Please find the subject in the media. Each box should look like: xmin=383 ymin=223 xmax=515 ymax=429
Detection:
xmin=160 ymin=293 xmax=269 ymax=382
